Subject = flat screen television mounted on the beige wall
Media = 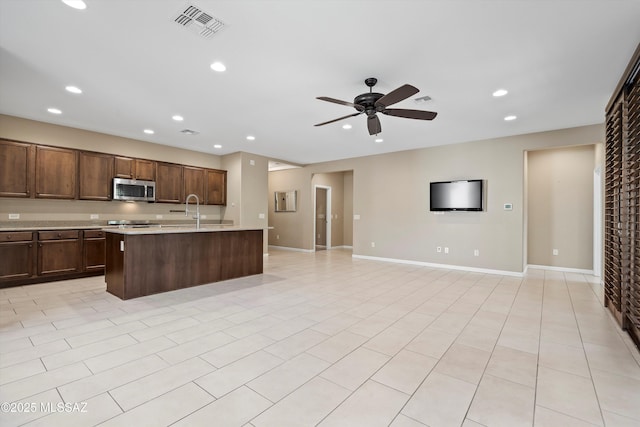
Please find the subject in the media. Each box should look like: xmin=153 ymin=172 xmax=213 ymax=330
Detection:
xmin=430 ymin=179 xmax=484 ymax=211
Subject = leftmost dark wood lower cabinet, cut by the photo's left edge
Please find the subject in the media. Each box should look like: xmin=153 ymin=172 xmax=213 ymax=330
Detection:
xmin=0 ymin=231 xmax=35 ymax=281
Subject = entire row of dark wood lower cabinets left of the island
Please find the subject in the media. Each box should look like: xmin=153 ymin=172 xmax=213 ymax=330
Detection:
xmin=0 ymin=230 xmax=106 ymax=288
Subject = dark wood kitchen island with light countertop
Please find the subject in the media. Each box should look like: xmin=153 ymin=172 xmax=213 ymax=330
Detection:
xmin=104 ymin=226 xmax=263 ymax=300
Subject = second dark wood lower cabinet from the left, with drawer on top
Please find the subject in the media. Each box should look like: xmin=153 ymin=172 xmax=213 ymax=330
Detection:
xmin=38 ymin=230 xmax=82 ymax=276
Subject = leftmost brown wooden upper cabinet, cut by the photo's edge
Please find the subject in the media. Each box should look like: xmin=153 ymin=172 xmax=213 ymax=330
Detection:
xmin=0 ymin=140 xmax=35 ymax=201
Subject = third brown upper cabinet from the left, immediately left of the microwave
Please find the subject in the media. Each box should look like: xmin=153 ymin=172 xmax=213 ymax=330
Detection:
xmin=78 ymin=152 xmax=114 ymax=200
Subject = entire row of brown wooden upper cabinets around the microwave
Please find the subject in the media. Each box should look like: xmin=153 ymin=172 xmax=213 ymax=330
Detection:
xmin=0 ymin=139 xmax=227 ymax=206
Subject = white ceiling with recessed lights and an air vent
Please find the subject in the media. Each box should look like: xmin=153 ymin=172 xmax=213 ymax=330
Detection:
xmin=0 ymin=0 xmax=640 ymax=164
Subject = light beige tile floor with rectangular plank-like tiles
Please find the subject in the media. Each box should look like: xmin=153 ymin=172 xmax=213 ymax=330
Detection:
xmin=0 ymin=249 xmax=640 ymax=427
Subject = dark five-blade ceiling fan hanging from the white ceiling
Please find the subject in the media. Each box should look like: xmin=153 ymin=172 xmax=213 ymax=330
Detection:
xmin=315 ymin=77 xmax=438 ymax=135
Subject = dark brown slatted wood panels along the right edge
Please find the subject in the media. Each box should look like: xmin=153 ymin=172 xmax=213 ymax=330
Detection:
xmin=604 ymin=45 xmax=640 ymax=347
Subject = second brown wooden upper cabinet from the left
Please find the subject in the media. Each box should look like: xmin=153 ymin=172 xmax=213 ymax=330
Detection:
xmin=35 ymin=146 xmax=78 ymax=199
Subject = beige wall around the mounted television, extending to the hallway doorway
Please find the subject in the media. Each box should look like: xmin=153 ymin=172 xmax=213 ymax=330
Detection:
xmin=269 ymin=125 xmax=604 ymax=272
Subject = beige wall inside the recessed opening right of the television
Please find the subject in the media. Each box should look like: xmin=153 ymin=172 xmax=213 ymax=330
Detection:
xmin=527 ymin=145 xmax=596 ymax=270
